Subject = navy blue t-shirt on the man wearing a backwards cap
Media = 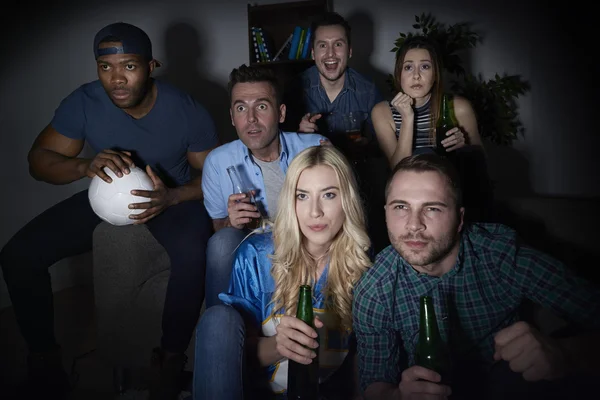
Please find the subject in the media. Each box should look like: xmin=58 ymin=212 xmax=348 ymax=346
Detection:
xmin=51 ymin=80 xmax=218 ymax=186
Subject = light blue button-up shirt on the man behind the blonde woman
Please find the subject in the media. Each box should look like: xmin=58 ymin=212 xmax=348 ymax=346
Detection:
xmin=202 ymin=132 xmax=327 ymax=219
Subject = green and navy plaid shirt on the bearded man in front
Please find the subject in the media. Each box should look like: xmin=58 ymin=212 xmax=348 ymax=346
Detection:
xmin=353 ymin=224 xmax=600 ymax=390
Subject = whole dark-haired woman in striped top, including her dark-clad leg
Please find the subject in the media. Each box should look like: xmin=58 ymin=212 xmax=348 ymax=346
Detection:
xmin=371 ymin=36 xmax=494 ymax=222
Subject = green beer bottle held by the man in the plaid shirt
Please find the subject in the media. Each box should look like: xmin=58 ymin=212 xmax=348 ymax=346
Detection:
xmin=415 ymin=296 xmax=451 ymax=385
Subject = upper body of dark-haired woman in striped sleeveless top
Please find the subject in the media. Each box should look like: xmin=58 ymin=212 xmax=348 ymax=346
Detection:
xmin=371 ymin=36 xmax=482 ymax=168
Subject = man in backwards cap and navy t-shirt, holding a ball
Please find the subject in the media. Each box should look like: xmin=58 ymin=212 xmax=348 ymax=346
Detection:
xmin=0 ymin=23 xmax=218 ymax=399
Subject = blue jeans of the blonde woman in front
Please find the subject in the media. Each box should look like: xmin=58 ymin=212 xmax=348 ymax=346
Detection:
xmin=192 ymin=304 xmax=356 ymax=400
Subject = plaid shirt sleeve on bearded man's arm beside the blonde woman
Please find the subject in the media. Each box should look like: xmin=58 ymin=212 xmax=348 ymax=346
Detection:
xmin=353 ymin=253 xmax=400 ymax=390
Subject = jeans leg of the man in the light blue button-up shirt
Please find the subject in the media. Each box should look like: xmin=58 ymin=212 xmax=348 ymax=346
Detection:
xmin=206 ymin=227 xmax=250 ymax=309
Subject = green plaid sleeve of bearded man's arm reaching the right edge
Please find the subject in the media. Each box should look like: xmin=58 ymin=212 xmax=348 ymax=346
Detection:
xmin=515 ymin=247 xmax=600 ymax=329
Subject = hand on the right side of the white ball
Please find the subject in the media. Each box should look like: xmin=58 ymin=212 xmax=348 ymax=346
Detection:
xmin=129 ymin=165 xmax=175 ymax=225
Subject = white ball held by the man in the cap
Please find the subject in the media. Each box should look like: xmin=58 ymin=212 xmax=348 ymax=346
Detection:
xmin=88 ymin=167 xmax=154 ymax=226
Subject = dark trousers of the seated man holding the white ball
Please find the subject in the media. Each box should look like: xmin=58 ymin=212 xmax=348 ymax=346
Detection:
xmin=0 ymin=190 xmax=210 ymax=353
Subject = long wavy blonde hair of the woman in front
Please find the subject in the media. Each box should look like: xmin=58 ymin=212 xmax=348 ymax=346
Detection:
xmin=271 ymin=145 xmax=371 ymax=329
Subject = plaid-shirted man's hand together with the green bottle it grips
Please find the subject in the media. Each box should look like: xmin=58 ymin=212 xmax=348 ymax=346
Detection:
xmin=400 ymin=296 xmax=451 ymax=399
